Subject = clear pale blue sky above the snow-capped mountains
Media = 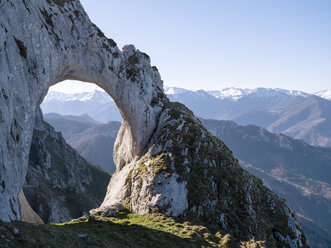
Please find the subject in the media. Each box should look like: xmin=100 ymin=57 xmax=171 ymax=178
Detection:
xmin=50 ymin=0 xmax=331 ymax=93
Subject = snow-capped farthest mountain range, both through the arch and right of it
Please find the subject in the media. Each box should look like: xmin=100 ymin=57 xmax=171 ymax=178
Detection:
xmin=41 ymin=87 xmax=331 ymax=147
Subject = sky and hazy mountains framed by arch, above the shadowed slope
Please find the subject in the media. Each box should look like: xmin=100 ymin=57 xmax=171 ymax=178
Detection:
xmin=41 ymin=80 xmax=122 ymax=173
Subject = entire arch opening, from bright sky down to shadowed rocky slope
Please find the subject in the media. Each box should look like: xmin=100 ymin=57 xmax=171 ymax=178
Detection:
xmin=23 ymin=80 xmax=126 ymax=223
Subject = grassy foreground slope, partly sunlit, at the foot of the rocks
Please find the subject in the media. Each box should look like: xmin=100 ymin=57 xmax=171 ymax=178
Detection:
xmin=0 ymin=212 xmax=264 ymax=248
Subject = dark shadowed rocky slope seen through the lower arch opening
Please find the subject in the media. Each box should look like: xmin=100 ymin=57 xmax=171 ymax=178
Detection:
xmin=23 ymin=109 xmax=110 ymax=223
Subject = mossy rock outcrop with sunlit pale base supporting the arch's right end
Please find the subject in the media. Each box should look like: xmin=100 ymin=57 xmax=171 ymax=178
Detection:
xmin=91 ymin=100 xmax=307 ymax=247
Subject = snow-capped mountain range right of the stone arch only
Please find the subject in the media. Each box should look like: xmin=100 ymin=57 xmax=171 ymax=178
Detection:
xmin=166 ymin=88 xmax=331 ymax=147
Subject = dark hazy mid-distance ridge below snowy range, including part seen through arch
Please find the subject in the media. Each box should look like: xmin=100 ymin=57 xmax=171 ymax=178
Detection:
xmin=45 ymin=115 xmax=331 ymax=247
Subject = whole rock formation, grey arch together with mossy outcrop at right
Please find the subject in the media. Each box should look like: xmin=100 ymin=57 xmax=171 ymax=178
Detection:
xmin=0 ymin=0 xmax=307 ymax=247
